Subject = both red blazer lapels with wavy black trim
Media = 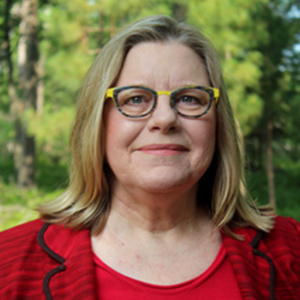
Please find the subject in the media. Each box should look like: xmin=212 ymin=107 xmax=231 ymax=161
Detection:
xmin=38 ymin=223 xmax=275 ymax=300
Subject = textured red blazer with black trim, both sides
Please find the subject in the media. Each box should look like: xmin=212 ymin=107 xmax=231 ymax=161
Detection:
xmin=0 ymin=217 xmax=300 ymax=300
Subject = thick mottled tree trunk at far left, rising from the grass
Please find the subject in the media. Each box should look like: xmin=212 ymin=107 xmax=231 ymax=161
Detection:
xmin=13 ymin=0 xmax=39 ymax=187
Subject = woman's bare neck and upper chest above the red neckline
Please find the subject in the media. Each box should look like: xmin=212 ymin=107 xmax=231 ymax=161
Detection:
xmin=92 ymin=182 xmax=222 ymax=284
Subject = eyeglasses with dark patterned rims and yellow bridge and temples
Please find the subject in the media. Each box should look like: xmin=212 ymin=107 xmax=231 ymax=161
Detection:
xmin=105 ymin=86 xmax=220 ymax=118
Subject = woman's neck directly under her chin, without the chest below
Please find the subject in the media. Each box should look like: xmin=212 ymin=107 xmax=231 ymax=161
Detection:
xmin=99 ymin=179 xmax=210 ymax=240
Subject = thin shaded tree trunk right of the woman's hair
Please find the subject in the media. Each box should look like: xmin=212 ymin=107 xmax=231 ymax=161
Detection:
xmin=266 ymin=120 xmax=276 ymax=209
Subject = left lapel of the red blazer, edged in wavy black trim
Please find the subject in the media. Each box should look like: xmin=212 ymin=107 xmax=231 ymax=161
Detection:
xmin=38 ymin=224 xmax=97 ymax=300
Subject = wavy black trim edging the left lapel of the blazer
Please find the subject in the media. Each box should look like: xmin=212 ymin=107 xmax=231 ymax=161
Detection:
xmin=37 ymin=223 xmax=66 ymax=300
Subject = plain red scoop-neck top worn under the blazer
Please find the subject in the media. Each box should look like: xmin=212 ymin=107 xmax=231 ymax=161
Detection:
xmin=94 ymin=245 xmax=242 ymax=300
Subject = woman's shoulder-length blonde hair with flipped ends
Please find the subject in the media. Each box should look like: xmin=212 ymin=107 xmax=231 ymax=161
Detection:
xmin=39 ymin=16 xmax=273 ymax=237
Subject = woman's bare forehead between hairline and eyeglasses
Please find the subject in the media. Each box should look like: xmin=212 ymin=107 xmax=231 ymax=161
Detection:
xmin=117 ymin=42 xmax=209 ymax=89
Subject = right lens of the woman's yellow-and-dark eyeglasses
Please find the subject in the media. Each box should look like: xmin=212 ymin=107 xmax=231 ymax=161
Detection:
xmin=173 ymin=88 xmax=210 ymax=116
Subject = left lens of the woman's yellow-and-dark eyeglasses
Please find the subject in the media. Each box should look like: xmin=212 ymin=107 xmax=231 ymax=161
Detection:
xmin=117 ymin=87 xmax=155 ymax=117
